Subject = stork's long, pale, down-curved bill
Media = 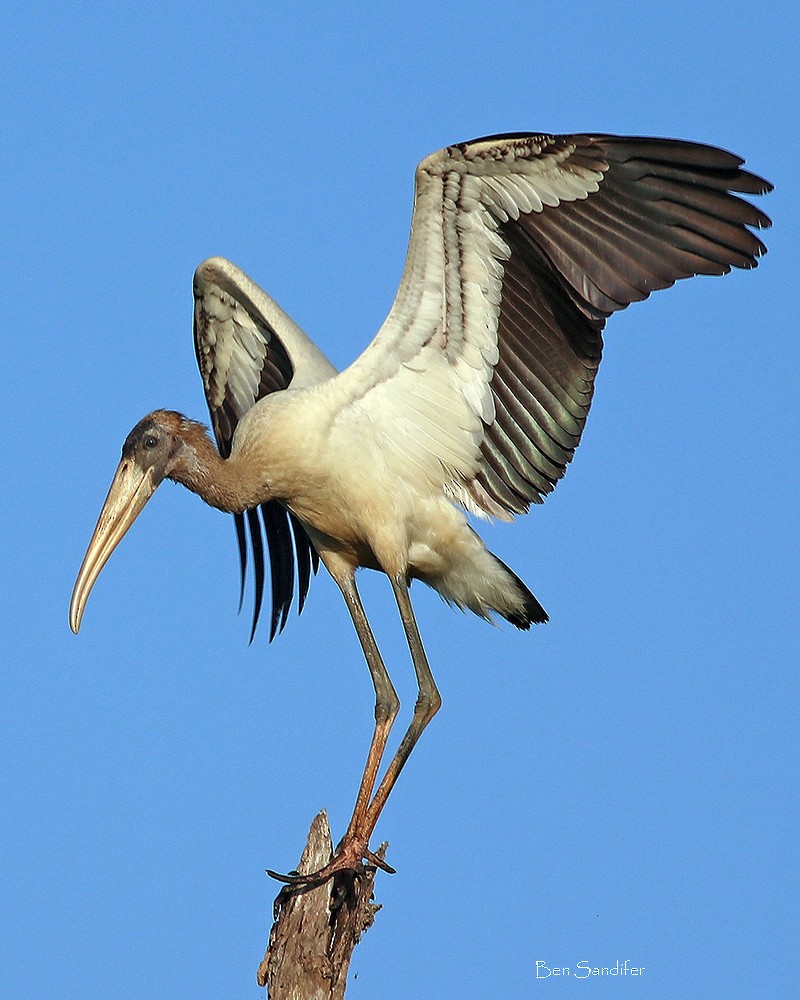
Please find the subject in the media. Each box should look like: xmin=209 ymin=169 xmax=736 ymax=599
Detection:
xmin=69 ymin=458 xmax=161 ymax=635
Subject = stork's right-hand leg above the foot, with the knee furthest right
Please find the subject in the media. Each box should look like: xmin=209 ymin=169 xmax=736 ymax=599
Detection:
xmin=358 ymin=576 xmax=442 ymax=842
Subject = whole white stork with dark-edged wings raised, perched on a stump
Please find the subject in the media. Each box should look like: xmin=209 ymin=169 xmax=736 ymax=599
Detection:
xmin=70 ymin=133 xmax=772 ymax=885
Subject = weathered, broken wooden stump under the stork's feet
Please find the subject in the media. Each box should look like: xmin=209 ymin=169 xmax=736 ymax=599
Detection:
xmin=256 ymin=810 xmax=386 ymax=1000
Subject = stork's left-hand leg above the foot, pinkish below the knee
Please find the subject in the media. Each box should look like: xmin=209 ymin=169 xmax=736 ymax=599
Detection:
xmin=337 ymin=574 xmax=400 ymax=867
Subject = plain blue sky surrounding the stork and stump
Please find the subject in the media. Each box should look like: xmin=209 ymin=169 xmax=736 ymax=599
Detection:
xmin=0 ymin=2 xmax=800 ymax=1000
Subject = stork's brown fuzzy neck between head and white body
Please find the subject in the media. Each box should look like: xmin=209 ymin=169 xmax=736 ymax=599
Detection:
xmin=169 ymin=421 xmax=271 ymax=514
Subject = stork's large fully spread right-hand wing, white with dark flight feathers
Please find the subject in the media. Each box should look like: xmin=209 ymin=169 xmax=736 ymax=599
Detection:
xmin=332 ymin=135 xmax=771 ymax=519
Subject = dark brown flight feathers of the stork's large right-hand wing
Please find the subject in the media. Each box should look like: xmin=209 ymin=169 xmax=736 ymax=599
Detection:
xmin=472 ymin=135 xmax=771 ymax=514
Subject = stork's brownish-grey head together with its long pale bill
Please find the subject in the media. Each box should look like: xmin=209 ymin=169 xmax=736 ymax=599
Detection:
xmin=69 ymin=410 xmax=184 ymax=633
